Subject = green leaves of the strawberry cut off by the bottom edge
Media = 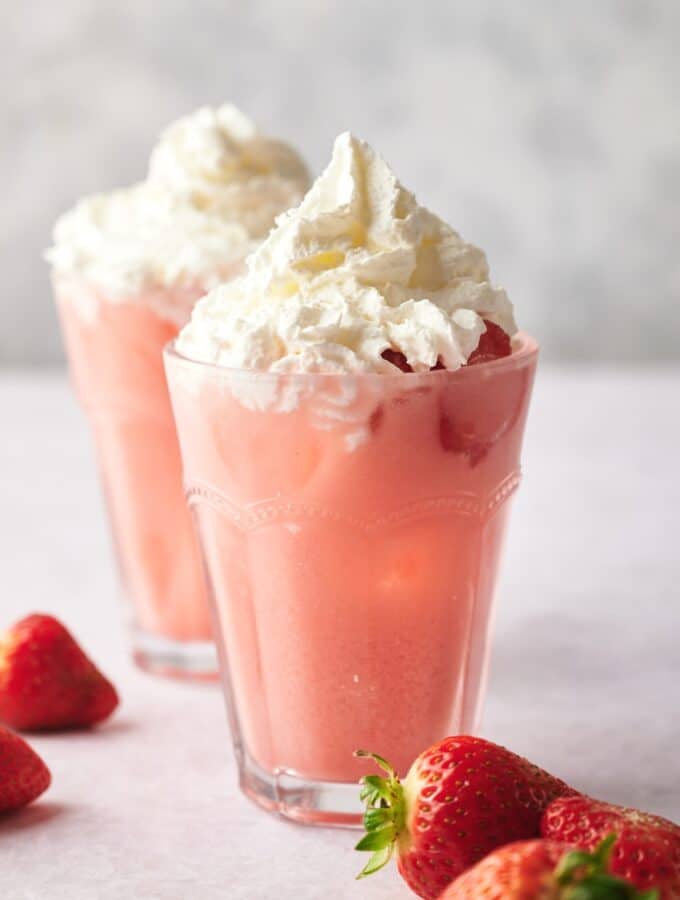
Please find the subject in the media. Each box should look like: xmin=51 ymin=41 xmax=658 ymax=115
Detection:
xmin=555 ymin=834 xmax=659 ymax=900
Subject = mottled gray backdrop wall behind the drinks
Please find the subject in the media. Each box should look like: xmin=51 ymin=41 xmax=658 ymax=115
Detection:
xmin=0 ymin=0 xmax=680 ymax=364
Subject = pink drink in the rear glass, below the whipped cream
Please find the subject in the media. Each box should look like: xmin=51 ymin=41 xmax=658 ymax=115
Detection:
xmin=55 ymin=282 xmax=212 ymax=641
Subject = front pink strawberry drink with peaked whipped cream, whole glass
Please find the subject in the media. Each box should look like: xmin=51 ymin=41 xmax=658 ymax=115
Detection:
xmin=166 ymin=134 xmax=537 ymax=824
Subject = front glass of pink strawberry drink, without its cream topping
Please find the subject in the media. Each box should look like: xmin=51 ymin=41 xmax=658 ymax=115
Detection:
xmin=165 ymin=337 xmax=538 ymax=824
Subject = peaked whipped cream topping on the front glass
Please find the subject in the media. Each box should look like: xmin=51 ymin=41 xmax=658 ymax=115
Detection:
xmin=177 ymin=133 xmax=516 ymax=374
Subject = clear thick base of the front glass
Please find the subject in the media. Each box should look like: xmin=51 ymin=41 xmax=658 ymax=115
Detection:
xmin=239 ymin=757 xmax=363 ymax=828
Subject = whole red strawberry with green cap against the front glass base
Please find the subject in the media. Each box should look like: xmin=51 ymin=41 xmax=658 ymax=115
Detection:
xmin=357 ymin=735 xmax=574 ymax=900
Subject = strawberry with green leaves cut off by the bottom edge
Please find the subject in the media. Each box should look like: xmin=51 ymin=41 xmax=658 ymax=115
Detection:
xmin=440 ymin=834 xmax=659 ymax=900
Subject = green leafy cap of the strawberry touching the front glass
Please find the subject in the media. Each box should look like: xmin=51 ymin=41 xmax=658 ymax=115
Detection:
xmin=354 ymin=750 xmax=406 ymax=878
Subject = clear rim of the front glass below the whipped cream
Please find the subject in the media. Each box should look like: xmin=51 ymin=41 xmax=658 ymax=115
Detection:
xmin=163 ymin=331 xmax=540 ymax=382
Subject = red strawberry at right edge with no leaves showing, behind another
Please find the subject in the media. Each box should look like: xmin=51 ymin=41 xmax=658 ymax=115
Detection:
xmin=541 ymin=797 xmax=680 ymax=900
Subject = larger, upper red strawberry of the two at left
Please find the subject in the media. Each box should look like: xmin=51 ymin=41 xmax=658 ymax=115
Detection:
xmin=0 ymin=615 xmax=118 ymax=731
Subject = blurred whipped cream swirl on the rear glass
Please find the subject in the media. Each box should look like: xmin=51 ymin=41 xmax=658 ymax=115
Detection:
xmin=47 ymin=104 xmax=309 ymax=300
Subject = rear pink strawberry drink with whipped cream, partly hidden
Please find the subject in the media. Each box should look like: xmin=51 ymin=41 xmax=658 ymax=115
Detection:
xmin=47 ymin=105 xmax=308 ymax=677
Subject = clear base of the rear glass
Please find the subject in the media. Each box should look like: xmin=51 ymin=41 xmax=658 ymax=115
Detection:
xmin=132 ymin=628 xmax=219 ymax=681
